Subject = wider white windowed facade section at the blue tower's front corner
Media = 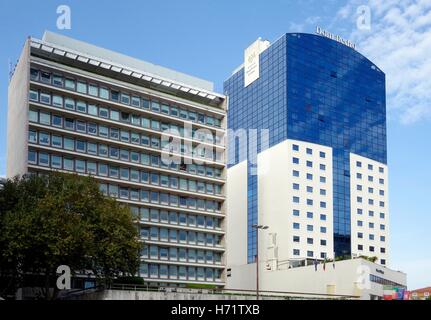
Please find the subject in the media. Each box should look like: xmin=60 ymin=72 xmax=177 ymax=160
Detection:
xmin=258 ymin=140 xmax=334 ymax=268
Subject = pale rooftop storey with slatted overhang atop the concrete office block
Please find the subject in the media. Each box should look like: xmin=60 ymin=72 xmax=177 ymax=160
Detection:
xmin=30 ymin=31 xmax=225 ymax=106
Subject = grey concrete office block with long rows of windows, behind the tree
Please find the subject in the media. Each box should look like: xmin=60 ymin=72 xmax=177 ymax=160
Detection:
xmin=7 ymin=32 xmax=226 ymax=287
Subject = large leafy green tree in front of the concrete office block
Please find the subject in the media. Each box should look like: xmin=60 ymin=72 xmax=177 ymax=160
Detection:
xmin=0 ymin=173 xmax=140 ymax=299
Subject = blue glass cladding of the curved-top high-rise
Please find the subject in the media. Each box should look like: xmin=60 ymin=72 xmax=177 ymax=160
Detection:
xmin=224 ymin=33 xmax=387 ymax=264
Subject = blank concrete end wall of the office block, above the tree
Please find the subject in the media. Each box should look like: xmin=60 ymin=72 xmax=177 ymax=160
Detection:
xmin=7 ymin=41 xmax=30 ymax=178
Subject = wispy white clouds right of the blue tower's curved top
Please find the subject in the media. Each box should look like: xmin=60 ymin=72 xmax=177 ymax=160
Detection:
xmin=336 ymin=0 xmax=431 ymax=124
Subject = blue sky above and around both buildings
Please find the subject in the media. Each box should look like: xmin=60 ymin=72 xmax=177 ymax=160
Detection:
xmin=0 ymin=0 xmax=431 ymax=289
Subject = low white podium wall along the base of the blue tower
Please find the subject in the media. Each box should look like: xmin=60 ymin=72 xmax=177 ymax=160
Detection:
xmin=226 ymin=259 xmax=407 ymax=299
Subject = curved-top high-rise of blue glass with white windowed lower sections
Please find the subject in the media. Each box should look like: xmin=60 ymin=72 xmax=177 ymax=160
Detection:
xmin=224 ymin=33 xmax=389 ymax=265
